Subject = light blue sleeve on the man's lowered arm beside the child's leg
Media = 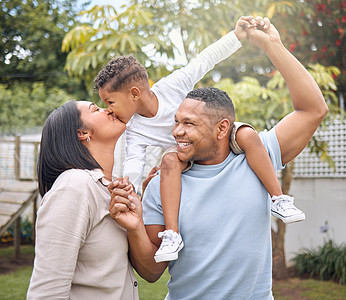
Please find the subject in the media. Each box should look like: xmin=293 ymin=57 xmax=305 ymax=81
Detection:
xmin=143 ymin=175 xmax=165 ymax=225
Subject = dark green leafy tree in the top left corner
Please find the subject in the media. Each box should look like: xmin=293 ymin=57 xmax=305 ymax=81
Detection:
xmin=0 ymin=0 xmax=85 ymax=95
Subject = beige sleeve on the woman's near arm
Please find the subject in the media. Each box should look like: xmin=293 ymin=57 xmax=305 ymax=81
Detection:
xmin=27 ymin=186 xmax=90 ymax=299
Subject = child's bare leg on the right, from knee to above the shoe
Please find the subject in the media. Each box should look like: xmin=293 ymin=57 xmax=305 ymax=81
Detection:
xmin=235 ymin=126 xmax=282 ymax=197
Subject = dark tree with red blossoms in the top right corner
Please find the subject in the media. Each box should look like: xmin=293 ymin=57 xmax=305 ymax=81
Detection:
xmin=275 ymin=0 xmax=346 ymax=105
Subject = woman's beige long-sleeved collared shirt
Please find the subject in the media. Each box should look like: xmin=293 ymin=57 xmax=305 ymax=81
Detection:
xmin=27 ymin=169 xmax=138 ymax=300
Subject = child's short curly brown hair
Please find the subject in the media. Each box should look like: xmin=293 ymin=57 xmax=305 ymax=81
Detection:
xmin=94 ymin=55 xmax=148 ymax=92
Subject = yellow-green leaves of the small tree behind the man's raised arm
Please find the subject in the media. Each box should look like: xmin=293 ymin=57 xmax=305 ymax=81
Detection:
xmin=214 ymin=64 xmax=345 ymax=170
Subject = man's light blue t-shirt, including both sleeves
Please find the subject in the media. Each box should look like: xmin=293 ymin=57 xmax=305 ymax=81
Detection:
xmin=143 ymin=129 xmax=282 ymax=300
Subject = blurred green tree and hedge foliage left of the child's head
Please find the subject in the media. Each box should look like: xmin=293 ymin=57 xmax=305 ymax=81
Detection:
xmin=0 ymin=0 xmax=87 ymax=133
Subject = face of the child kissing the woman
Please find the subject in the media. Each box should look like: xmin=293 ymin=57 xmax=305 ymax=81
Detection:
xmin=99 ymin=86 xmax=136 ymax=124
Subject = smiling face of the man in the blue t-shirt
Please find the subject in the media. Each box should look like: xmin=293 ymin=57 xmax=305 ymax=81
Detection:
xmin=173 ymin=98 xmax=220 ymax=165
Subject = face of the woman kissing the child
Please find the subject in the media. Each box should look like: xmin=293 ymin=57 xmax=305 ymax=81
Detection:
xmin=77 ymin=101 xmax=126 ymax=142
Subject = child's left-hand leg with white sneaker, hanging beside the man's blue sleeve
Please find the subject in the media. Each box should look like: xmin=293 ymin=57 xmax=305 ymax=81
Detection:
xmin=154 ymin=152 xmax=187 ymax=263
